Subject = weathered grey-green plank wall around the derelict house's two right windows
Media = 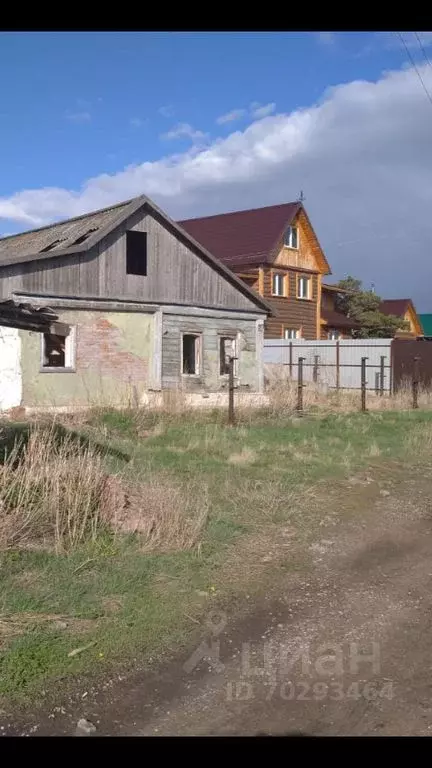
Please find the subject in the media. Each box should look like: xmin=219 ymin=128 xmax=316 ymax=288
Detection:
xmin=162 ymin=314 xmax=262 ymax=392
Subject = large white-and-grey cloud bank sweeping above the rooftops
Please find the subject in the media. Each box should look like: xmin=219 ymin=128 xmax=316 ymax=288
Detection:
xmin=0 ymin=64 xmax=432 ymax=311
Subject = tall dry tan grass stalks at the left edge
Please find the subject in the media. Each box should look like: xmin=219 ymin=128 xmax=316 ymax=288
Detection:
xmin=0 ymin=425 xmax=105 ymax=551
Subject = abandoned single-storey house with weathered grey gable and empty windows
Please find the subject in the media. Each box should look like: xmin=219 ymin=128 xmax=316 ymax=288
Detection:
xmin=0 ymin=196 xmax=272 ymax=410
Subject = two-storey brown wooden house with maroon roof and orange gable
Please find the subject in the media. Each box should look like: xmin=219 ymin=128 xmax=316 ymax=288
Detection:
xmin=179 ymin=202 xmax=330 ymax=339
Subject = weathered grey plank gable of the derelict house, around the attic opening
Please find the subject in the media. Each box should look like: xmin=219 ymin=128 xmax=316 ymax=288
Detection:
xmin=0 ymin=207 xmax=262 ymax=312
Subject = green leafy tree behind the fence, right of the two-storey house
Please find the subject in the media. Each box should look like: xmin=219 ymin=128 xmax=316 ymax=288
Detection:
xmin=336 ymin=276 xmax=409 ymax=339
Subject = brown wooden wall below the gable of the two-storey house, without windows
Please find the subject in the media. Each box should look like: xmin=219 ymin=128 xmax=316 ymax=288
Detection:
xmin=264 ymin=268 xmax=318 ymax=339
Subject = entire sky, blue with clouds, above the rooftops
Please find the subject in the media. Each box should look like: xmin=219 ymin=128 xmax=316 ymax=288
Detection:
xmin=0 ymin=32 xmax=432 ymax=312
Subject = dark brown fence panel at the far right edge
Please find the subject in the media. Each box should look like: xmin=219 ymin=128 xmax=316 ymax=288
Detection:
xmin=392 ymin=339 xmax=432 ymax=392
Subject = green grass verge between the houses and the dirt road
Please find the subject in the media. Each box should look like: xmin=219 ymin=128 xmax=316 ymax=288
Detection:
xmin=0 ymin=411 xmax=432 ymax=699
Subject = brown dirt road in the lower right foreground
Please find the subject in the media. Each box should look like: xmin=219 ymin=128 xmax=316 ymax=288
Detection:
xmin=3 ymin=468 xmax=432 ymax=736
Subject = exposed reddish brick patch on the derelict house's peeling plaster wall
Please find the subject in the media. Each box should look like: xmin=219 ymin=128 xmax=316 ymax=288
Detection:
xmin=76 ymin=317 xmax=148 ymax=382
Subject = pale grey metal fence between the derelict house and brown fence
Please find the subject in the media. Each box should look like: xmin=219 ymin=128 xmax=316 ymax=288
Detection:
xmin=263 ymin=339 xmax=392 ymax=393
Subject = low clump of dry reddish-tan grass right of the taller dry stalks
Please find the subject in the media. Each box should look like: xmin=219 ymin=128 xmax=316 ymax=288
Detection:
xmin=102 ymin=473 xmax=209 ymax=552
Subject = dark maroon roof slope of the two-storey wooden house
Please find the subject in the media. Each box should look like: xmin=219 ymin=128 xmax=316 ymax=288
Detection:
xmin=177 ymin=202 xmax=302 ymax=268
